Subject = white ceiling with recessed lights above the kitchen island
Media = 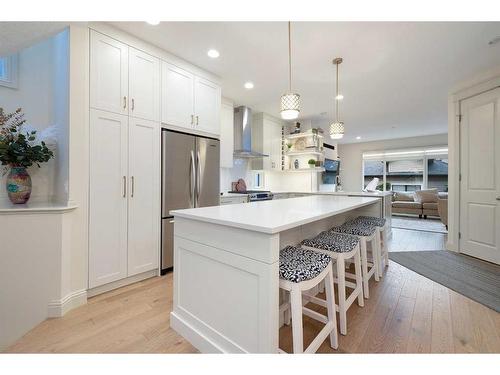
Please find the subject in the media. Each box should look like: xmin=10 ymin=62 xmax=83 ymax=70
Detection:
xmin=113 ymin=22 xmax=500 ymax=143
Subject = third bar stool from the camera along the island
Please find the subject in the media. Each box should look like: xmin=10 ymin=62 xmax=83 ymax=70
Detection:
xmin=330 ymin=221 xmax=380 ymax=298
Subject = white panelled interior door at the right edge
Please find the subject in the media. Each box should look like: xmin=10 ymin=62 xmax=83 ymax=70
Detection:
xmin=460 ymin=89 xmax=500 ymax=264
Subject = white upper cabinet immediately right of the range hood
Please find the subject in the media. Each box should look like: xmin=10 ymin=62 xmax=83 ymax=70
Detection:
xmin=252 ymin=113 xmax=284 ymax=171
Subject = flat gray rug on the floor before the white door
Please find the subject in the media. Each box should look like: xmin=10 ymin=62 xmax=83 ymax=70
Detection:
xmin=389 ymin=250 xmax=500 ymax=312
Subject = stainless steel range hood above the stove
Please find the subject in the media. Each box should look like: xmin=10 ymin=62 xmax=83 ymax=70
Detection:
xmin=233 ymin=106 xmax=269 ymax=158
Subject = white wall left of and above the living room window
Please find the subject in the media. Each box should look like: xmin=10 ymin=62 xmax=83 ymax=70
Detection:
xmin=338 ymin=134 xmax=448 ymax=191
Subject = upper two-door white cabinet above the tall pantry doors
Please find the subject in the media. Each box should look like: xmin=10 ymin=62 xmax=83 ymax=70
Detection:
xmin=90 ymin=30 xmax=160 ymax=121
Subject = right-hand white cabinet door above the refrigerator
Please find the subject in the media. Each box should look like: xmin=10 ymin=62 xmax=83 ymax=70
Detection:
xmin=194 ymin=77 xmax=221 ymax=135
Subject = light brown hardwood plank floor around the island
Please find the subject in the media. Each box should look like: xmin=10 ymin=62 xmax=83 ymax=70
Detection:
xmin=7 ymin=230 xmax=500 ymax=353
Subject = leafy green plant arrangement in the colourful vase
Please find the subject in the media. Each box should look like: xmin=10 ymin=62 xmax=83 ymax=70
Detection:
xmin=0 ymin=107 xmax=54 ymax=168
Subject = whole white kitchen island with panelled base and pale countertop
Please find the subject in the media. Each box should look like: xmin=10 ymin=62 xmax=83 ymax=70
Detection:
xmin=170 ymin=195 xmax=383 ymax=353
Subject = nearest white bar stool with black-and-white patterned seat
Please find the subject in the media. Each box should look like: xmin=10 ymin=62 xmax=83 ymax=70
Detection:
xmin=279 ymin=246 xmax=338 ymax=353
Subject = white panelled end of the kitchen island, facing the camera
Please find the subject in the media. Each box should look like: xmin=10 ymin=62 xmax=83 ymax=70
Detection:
xmin=171 ymin=218 xmax=279 ymax=353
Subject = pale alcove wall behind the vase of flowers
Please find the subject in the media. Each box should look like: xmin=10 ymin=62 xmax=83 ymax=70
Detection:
xmin=0 ymin=31 xmax=69 ymax=204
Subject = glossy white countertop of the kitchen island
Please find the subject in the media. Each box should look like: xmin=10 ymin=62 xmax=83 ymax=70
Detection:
xmin=170 ymin=195 xmax=379 ymax=234
